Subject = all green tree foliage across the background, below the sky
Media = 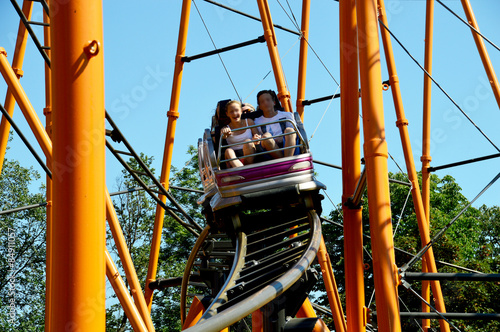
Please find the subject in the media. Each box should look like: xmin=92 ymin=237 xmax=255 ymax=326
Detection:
xmin=0 ymin=147 xmax=500 ymax=331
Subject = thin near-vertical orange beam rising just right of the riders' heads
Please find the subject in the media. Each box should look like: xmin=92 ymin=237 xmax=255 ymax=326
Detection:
xmin=297 ymin=0 xmax=311 ymax=121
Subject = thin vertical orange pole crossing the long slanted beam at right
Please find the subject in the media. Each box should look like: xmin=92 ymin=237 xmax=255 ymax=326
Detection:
xmin=420 ymin=0 xmax=434 ymax=332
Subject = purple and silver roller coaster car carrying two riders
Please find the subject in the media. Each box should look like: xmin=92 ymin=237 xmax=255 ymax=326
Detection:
xmin=198 ymin=109 xmax=325 ymax=212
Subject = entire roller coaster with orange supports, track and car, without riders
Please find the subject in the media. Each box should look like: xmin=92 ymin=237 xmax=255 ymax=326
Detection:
xmin=0 ymin=0 xmax=500 ymax=331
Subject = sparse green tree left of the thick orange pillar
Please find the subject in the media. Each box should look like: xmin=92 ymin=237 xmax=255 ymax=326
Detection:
xmin=0 ymin=159 xmax=46 ymax=331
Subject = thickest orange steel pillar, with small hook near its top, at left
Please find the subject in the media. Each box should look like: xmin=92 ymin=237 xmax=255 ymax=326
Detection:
xmin=49 ymin=0 xmax=106 ymax=331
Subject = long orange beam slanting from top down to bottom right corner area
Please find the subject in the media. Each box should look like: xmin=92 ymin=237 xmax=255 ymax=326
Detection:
xmin=378 ymin=0 xmax=450 ymax=331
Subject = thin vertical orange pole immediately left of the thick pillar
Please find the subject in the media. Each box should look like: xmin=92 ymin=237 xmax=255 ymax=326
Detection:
xmin=42 ymin=1 xmax=52 ymax=331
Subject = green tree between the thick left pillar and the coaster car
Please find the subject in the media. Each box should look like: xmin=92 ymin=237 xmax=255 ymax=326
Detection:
xmin=107 ymin=146 xmax=203 ymax=331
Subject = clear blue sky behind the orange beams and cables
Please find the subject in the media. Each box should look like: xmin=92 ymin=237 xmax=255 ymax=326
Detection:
xmin=0 ymin=0 xmax=500 ymax=212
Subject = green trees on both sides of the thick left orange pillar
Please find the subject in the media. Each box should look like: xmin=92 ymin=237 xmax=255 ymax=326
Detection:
xmin=0 ymin=143 xmax=203 ymax=331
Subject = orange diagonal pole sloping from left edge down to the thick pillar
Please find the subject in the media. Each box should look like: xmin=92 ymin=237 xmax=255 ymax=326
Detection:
xmin=0 ymin=47 xmax=51 ymax=160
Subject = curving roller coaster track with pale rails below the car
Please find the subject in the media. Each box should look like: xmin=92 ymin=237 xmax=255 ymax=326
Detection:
xmin=181 ymin=200 xmax=321 ymax=331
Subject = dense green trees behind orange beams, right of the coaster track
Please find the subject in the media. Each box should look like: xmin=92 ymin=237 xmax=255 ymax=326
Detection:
xmin=318 ymin=173 xmax=500 ymax=331
